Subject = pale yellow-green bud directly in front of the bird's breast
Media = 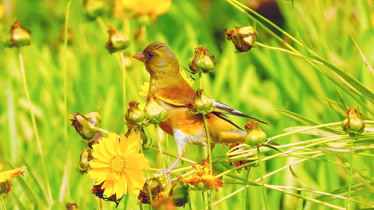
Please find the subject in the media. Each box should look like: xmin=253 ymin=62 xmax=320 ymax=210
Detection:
xmin=144 ymin=98 xmax=168 ymax=124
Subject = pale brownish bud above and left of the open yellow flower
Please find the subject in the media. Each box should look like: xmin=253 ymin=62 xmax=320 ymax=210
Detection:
xmin=70 ymin=112 xmax=101 ymax=140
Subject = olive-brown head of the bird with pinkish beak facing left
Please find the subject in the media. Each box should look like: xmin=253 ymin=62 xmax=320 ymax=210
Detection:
xmin=133 ymin=42 xmax=179 ymax=75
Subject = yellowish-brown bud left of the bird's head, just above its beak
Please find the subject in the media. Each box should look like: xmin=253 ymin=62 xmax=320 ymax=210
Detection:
xmin=105 ymin=25 xmax=130 ymax=53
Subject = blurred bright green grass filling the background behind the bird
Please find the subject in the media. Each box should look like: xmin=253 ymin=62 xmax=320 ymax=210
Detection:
xmin=0 ymin=0 xmax=374 ymax=209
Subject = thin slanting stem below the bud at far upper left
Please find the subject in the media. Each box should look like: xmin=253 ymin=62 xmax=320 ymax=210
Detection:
xmin=17 ymin=48 xmax=52 ymax=205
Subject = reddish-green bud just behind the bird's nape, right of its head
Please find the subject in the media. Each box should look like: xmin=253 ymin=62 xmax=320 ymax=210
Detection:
xmin=189 ymin=46 xmax=216 ymax=74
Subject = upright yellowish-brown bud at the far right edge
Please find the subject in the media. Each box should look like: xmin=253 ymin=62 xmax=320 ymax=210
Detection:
xmin=342 ymin=108 xmax=365 ymax=135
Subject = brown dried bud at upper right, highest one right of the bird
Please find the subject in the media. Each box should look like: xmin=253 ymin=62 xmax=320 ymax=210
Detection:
xmin=225 ymin=26 xmax=257 ymax=52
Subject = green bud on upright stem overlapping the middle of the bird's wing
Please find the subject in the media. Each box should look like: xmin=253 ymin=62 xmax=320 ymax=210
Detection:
xmin=191 ymin=89 xmax=214 ymax=115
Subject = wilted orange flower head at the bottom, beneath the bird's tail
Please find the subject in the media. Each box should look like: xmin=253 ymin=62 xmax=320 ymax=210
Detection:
xmin=179 ymin=163 xmax=223 ymax=191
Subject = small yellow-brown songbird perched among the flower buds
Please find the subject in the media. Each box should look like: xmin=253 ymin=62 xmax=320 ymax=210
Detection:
xmin=133 ymin=42 xmax=264 ymax=172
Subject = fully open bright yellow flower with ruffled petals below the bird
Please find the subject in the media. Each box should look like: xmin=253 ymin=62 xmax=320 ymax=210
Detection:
xmin=88 ymin=133 xmax=149 ymax=201
